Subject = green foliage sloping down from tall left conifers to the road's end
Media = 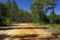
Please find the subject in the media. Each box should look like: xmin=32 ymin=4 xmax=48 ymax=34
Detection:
xmin=6 ymin=0 xmax=31 ymax=22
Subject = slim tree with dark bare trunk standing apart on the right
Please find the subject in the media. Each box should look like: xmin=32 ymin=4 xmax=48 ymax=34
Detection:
xmin=47 ymin=0 xmax=56 ymax=23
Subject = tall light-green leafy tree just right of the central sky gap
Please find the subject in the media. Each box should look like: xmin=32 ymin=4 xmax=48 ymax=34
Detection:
xmin=31 ymin=0 xmax=49 ymax=23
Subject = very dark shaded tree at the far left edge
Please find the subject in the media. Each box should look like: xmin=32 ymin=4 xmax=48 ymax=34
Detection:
xmin=0 ymin=3 xmax=8 ymax=25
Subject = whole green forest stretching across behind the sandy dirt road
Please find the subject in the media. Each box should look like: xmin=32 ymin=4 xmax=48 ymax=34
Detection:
xmin=0 ymin=0 xmax=60 ymax=29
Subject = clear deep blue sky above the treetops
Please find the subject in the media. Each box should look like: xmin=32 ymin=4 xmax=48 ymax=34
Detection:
xmin=0 ymin=0 xmax=60 ymax=15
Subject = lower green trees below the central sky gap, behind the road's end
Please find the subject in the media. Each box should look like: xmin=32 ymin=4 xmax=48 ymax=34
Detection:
xmin=18 ymin=9 xmax=32 ymax=23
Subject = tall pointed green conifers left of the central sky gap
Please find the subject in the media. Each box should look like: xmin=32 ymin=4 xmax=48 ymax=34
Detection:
xmin=6 ymin=0 xmax=19 ymax=22
